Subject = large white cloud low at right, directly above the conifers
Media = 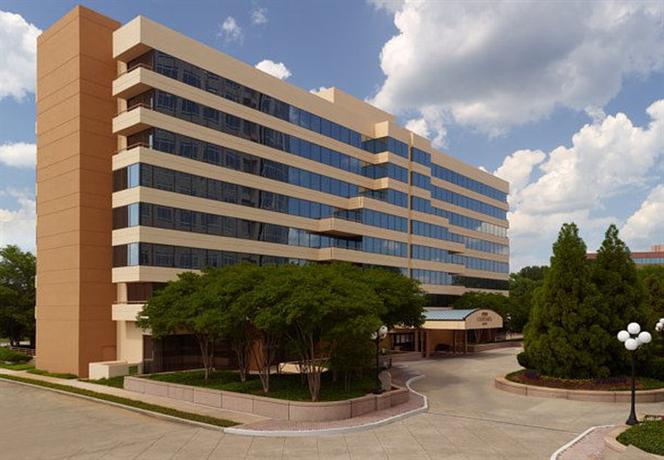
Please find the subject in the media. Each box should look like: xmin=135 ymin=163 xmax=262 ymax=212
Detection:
xmin=495 ymin=99 xmax=664 ymax=269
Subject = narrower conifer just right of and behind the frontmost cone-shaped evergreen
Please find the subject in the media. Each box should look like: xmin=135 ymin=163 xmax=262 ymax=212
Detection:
xmin=592 ymin=224 xmax=652 ymax=374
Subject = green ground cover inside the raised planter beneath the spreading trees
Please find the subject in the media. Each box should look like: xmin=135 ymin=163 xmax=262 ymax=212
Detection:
xmin=146 ymin=371 xmax=375 ymax=401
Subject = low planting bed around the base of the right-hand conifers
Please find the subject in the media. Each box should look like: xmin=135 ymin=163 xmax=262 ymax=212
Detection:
xmin=505 ymin=369 xmax=664 ymax=391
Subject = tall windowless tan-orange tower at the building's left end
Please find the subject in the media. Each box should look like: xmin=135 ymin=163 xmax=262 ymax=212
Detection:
xmin=36 ymin=6 xmax=120 ymax=376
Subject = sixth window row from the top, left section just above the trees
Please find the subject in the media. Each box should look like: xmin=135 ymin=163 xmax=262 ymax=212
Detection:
xmin=113 ymin=243 xmax=308 ymax=270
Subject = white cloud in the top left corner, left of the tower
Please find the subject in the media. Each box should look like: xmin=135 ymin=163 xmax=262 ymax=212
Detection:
xmin=0 ymin=11 xmax=41 ymax=100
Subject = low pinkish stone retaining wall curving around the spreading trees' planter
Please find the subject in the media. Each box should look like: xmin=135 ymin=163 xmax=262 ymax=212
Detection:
xmin=124 ymin=377 xmax=410 ymax=422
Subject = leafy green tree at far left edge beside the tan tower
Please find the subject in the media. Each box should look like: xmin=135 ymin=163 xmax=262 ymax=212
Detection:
xmin=0 ymin=245 xmax=36 ymax=346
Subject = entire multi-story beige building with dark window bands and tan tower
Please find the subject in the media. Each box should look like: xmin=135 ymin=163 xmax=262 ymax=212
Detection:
xmin=37 ymin=7 xmax=509 ymax=375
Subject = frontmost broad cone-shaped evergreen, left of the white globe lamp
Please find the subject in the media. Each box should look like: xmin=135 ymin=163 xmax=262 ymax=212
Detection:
xmin=524 ymin=223 xmax=615 ymax=378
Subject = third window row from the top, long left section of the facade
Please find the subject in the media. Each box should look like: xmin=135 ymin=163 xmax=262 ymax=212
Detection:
xmin=127 ymin=128 xmax=358 ymax=198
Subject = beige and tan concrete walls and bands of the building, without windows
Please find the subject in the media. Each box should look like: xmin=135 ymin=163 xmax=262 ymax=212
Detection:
xmin=37 ymin=8 xmax=509 ymax=375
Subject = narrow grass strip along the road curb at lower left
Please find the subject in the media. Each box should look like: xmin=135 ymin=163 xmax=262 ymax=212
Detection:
xmin=0 ymin=375 xmax=237 ymax=427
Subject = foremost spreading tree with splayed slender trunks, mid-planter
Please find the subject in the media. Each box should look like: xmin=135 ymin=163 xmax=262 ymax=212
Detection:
xmin=274 ymin=264 xmax=381 ymax=401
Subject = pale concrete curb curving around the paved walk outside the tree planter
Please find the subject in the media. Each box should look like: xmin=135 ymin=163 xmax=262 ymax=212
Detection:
xmin=224 ymin=374 xmax=429 ymax=438
